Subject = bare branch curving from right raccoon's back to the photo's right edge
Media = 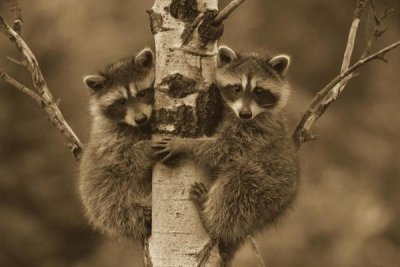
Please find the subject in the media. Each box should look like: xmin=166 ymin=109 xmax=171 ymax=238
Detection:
xmin=293 ymin=41 xmax=400 ymax=146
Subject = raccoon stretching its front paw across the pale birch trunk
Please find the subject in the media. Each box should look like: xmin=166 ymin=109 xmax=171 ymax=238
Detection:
xmin=153 ymin=47 xmax=299 ymax=266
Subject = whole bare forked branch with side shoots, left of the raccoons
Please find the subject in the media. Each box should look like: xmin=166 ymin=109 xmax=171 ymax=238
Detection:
xmin=0 ymin=7 xmax=82 ymax=160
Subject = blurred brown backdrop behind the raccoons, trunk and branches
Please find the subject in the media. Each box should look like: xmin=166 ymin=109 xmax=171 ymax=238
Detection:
xmin=0 ymin=0 xmax=400 ymax=267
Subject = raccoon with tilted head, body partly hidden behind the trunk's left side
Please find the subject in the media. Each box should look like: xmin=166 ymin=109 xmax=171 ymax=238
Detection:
xmin=79 ymin=49 xmax=154 ymax=240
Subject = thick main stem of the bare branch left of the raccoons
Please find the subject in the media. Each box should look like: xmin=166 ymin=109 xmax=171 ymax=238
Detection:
xmin=0 ymin=14 xmax=82 ymax=160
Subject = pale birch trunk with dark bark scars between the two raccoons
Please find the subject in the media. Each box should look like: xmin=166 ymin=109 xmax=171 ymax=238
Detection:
xmin=149 ymin=0 xmax=222 ymax=267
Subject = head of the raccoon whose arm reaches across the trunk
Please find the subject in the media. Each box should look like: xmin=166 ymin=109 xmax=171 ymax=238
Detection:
xmin=216 ymin=46 xmax=290 ymax=120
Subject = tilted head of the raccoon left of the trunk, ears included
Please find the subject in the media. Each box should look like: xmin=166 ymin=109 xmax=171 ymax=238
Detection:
xmin=84 ymin=49 xmax=154 ymax=127
